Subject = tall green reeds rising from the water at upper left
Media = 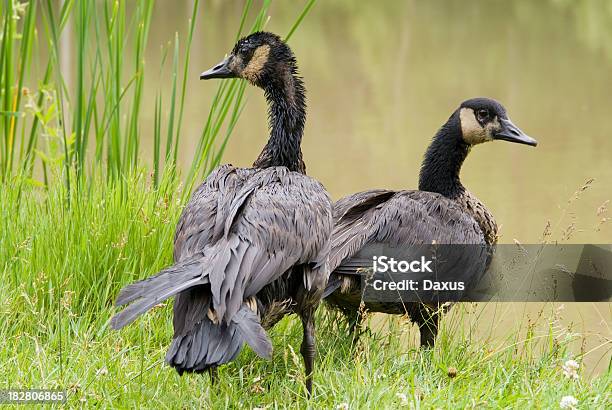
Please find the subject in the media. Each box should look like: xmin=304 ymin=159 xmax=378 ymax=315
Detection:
xmin=0 ymin=0 xmax=315 ymax=194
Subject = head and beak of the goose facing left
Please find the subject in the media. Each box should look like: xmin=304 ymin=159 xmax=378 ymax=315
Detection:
xmin=200 ymin=31 xmax=295 ymax=87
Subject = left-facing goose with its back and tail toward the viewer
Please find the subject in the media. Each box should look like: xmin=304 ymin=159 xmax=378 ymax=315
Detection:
xmin=111 ymin=32 xmax=333 ymax=393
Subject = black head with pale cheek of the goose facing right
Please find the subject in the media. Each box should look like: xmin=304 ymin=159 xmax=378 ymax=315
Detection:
xmin=459 ymin=98 xmax=538 ymax=147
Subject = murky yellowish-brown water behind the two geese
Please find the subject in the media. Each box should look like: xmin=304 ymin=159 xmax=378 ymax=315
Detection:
xmin=75 ymin=0 xmax=612 ymax=371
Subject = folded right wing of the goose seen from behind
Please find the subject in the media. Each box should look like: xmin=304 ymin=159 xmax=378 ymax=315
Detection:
xmin=210 ymin=168 xmax=332 ymax=319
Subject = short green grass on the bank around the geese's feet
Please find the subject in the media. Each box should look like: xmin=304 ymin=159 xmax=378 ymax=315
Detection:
xmin=0 ymin=172 xmax=612 ymax=408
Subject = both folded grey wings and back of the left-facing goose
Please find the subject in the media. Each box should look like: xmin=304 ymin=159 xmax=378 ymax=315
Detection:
xmin=114 ymin=166 xmax=332 ymax=335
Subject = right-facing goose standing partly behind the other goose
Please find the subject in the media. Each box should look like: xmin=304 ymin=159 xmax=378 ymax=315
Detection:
xmin=324 ymin=98 xmax=537 ymax=347
